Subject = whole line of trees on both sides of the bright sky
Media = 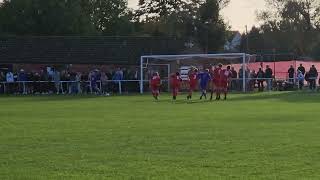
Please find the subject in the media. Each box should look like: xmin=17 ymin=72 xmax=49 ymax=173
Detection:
xmin=0 ymin=0 xmax=320 ymax=57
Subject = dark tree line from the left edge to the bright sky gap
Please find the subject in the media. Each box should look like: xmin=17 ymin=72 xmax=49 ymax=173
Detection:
xmin=0 ymin=0 xmax=229 ymax=51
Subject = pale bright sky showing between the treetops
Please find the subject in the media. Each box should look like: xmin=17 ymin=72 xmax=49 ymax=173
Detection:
xmin=128 ymin=0 xmax=265 ymax=32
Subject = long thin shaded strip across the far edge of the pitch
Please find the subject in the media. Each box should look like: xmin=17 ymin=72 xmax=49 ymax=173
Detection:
xmin=0 ymin=91 xmax=320 ymax=104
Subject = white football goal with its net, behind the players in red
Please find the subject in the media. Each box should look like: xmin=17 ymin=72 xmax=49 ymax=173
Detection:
xmin=140 ymin=53 xmax=255 ymax=94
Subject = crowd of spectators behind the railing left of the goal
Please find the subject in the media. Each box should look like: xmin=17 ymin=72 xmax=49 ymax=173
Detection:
xmin=0 ymin=68 xmax=139 ymax=95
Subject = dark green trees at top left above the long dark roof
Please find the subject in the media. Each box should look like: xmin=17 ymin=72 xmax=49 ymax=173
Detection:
xmin=0 ymin=0 xmax=132 ymax=35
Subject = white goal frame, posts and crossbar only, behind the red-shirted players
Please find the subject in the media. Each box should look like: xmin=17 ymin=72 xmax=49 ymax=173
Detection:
xmin=140 ymin=53 xmax=251 ymax=94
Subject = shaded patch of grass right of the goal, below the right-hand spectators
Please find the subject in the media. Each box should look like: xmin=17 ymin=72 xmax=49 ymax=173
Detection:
xmin=230 ymin=91 xmax=320 ymax=103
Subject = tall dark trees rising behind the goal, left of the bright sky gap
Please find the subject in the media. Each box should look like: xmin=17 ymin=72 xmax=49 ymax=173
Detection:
xmin=136 ymin=0 xmax=229 ymax=52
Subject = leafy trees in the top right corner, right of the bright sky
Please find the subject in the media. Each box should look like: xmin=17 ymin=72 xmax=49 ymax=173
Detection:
xmin=250 ymin=0 xmax=320 ymax=56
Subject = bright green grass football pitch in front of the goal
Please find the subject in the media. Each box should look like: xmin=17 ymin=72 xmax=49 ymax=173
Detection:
xmin=0 ymin=92 xmax=320 ymax=180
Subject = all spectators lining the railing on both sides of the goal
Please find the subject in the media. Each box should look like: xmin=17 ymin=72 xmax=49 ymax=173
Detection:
xmin=0 ymin=64 xmax=320 ymax=95
